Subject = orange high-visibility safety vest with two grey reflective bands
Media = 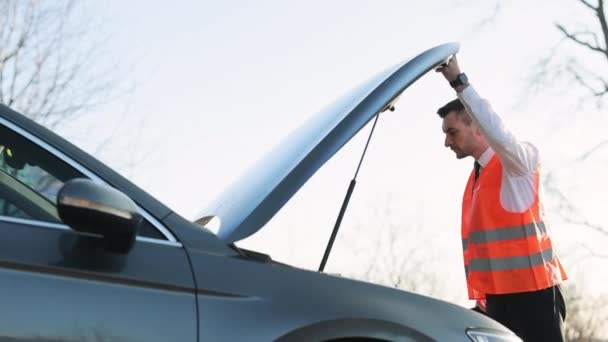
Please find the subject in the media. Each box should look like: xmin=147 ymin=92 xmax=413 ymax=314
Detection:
xmin=462 ymin=155 xmax=567 ymax=299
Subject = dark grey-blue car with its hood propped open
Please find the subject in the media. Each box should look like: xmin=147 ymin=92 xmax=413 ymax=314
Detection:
xmin=0 ymin=43 xmax=519 ymax=342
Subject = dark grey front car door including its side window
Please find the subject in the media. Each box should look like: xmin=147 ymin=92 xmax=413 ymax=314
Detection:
xmin=0 ymin=118 xmax=197 ymax=341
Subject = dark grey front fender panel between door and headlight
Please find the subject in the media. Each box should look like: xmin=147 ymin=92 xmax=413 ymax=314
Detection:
xmin=190 ymin=247 xmax=504 ymax=341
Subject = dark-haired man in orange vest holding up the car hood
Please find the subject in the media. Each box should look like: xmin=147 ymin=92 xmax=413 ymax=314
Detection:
xmin=437 ymin=56 xmax=567 ymax=342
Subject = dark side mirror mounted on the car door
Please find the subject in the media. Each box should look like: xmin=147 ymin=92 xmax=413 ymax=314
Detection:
xmin=57 ymin=178 xmax=142 ymax=254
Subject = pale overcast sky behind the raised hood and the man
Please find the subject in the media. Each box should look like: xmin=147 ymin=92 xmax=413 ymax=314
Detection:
xmin=64 ymin=0 xmax=608 ymax=302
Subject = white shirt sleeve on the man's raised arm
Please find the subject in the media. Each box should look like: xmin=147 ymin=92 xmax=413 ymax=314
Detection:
xmin=458 ymin=85 xmax=540 ymax=177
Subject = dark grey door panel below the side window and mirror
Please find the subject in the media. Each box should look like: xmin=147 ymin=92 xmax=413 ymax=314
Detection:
xmin=0 ymin=218 xmax=197 ymax=342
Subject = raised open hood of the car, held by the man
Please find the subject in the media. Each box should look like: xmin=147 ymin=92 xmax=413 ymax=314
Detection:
xmin=196 ymin=43 xmax=459 ymax=243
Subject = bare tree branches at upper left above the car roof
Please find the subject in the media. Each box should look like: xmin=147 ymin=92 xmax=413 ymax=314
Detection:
xmin=0 ymin=0 xmax=118 ymax=128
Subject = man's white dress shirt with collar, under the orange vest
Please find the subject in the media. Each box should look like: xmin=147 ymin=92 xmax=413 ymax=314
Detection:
xmin=458 ymin=85 xmax=540 ymax=212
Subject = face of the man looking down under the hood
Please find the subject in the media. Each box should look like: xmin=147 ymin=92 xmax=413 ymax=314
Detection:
xmin=441 ymin=111 xmax=477 ymax=159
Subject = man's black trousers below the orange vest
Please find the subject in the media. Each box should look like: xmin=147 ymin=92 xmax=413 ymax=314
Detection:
xmin=486 ymin=285 xmax=566 ymax=342
